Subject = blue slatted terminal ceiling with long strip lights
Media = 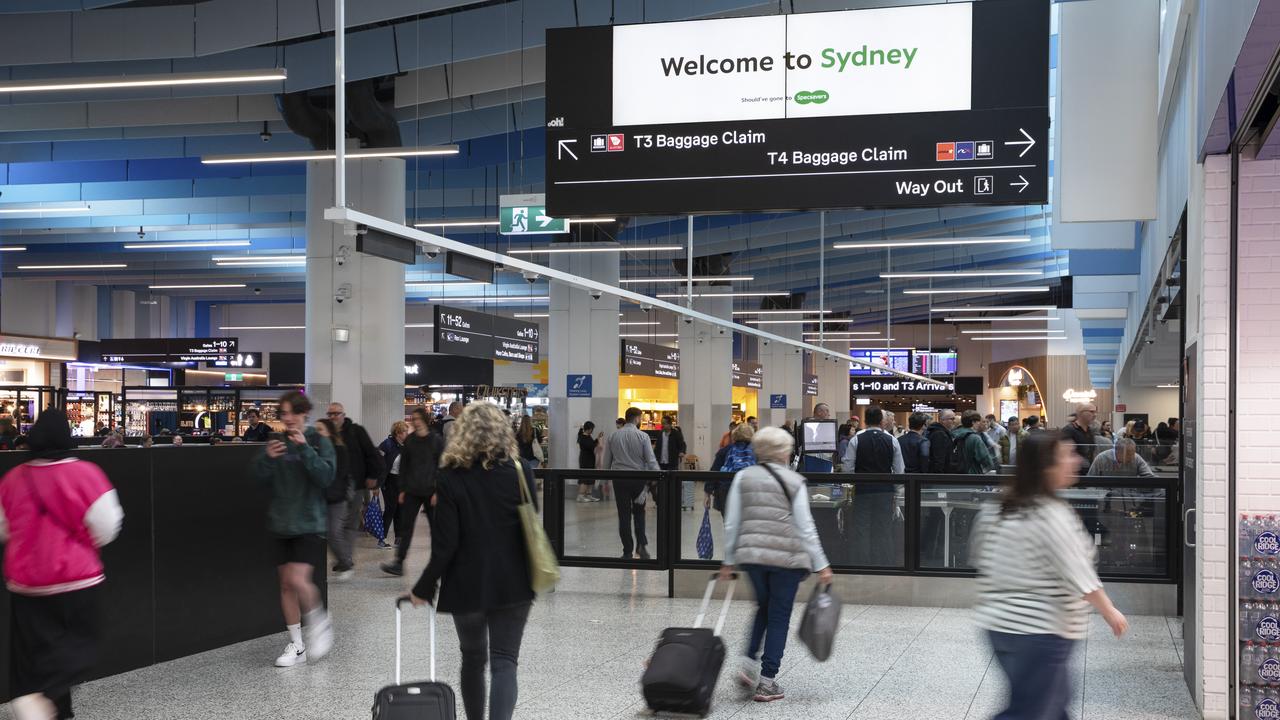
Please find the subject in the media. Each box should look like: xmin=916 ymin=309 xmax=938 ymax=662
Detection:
xmin=0 ymin=0 xmax=1070 ymax=324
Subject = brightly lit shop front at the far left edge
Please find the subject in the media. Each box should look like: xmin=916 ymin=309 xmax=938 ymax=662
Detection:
xmin=0 ymin=334 xmax=76 ymax=433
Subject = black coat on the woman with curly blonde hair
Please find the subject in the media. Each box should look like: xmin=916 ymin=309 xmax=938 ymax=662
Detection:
xmin=412 ymin=460 xmax=538 ymax=614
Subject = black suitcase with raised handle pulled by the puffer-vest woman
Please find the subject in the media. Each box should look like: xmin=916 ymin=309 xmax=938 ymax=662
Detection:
xmin=640 ymin=575 xmax=737 ymax=717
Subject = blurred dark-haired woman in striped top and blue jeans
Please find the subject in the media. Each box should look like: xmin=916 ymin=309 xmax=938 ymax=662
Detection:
xmin=970 ymin=433 xmax=1129 ymax=720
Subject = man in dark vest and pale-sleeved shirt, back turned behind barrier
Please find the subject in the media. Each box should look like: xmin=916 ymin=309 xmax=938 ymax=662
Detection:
xmin=844 ymin=405 xmax=906 ymax=566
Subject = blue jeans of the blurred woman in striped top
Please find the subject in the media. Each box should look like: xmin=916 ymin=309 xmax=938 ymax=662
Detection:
xmin=987 ymin=632 xmax=1075 ymax=720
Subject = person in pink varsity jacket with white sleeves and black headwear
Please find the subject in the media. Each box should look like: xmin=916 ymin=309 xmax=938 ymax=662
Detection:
xmin=0 ymin=409 xmax=124 ymax=720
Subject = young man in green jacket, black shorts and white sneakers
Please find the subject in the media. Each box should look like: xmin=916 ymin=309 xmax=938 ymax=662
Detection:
xmin=252 ymin=389 xmax=337 ymax=667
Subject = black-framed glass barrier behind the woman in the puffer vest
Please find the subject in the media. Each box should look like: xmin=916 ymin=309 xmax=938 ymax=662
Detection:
xmin=538 ymin=469 xmax=1180 ymax=589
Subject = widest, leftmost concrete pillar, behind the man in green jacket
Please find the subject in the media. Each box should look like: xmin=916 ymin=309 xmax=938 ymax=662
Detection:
xmin=306 ymin=158 xmax=404 ymax=437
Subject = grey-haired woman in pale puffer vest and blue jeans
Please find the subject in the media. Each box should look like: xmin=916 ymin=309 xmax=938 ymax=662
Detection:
xmin=721 ymin=428 xmax=832 ymax=702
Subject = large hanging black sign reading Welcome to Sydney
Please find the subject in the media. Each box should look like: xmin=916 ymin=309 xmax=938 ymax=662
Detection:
xmin=547 ymin=0 xmax=1050 ymax=217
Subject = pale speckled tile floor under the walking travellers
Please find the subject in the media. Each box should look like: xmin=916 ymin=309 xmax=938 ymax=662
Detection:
xmin=0 ymin=512 xmax=1199 ymax=720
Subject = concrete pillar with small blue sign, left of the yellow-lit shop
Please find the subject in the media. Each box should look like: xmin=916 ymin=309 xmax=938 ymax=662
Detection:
xmin=543 ymin=252 xmax=620 ymax=468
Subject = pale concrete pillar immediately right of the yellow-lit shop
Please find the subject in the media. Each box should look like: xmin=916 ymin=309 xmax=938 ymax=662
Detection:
xmin=680 ymin=297 xmax=733 ymax=470
